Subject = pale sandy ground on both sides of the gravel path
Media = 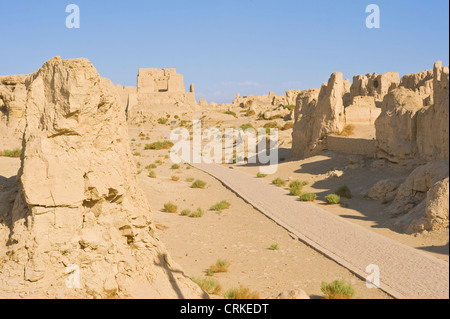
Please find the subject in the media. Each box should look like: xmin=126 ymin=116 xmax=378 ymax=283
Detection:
xmin=125 ymin=110 xmax=449 ymax=298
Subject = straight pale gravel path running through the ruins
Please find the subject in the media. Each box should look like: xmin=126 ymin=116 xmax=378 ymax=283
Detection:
xmin=192 ymin=164 xmax=449 ymax=299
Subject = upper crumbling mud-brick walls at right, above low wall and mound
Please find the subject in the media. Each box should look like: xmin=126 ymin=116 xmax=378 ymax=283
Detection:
xmin=292 ymin=62 xmax=449 ymax=162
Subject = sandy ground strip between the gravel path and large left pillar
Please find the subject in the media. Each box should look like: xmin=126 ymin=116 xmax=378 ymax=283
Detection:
xmin=125 ymin=127 xmax=390 ymax=298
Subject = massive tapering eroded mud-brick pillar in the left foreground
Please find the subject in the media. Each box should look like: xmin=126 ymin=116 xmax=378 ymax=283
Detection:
xmin=0 ymin=57 xmax=202 ymax=298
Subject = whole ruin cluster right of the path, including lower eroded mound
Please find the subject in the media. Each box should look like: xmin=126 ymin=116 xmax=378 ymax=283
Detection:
xmin=292 ymin=62 xmax=449 ymax=233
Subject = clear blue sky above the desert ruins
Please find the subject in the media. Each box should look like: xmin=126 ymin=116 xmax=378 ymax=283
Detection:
xmin=0 ymin=0 xmax=449 ymax=103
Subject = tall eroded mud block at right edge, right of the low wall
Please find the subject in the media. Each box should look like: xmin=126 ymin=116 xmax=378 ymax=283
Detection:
xmin=375 ymin=62 xmax=449 ymax=162
